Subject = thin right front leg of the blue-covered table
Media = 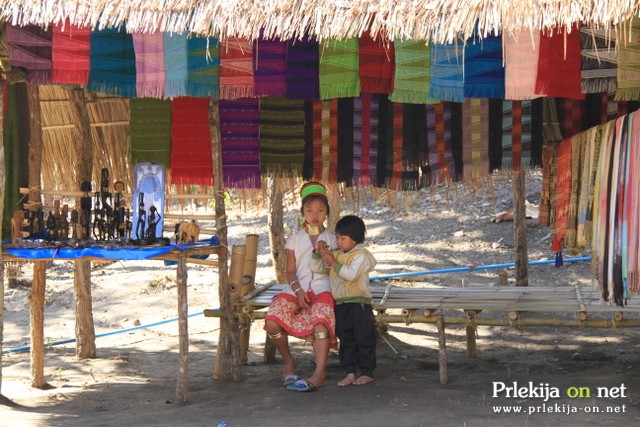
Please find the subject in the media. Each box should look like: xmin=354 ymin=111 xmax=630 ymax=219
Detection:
xmin=176 ymin=252 xmax=189 ymax=403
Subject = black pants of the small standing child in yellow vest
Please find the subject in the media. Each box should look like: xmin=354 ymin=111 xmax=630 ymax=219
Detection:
xmin=335 ymin=303 xmax=376 ymax=377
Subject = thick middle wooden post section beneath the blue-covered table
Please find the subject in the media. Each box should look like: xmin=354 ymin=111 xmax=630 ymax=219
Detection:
xmin=73 ymin=260 xmax=96 ymax=359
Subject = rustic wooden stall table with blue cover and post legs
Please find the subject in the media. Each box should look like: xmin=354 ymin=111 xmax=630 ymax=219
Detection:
xmin=2 ymin=241 xmax=226 ymax=403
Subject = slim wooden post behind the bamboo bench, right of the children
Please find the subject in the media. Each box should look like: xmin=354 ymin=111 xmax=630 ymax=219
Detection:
xmin=513 ymin=170 xmax=529 ymax=286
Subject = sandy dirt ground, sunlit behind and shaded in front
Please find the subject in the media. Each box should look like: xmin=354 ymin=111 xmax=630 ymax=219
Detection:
xmin=0 ymin=174 xmax=640 ymax=427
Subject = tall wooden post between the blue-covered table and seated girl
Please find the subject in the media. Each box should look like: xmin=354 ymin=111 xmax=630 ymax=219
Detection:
xmin=209 ymin=99 xmax=241 ymax=381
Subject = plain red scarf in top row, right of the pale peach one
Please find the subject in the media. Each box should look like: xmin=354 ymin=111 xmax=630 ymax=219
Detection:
xmin=536 ymin=26 xmax=584 ymax=99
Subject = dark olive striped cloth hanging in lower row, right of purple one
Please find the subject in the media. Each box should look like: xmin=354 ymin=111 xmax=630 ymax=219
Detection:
xmin=260 ymin=97 xmax=305 ymax=178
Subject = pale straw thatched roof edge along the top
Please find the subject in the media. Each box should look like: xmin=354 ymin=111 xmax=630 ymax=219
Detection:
xmin=0 ymin=0 xmax=640 ymax=43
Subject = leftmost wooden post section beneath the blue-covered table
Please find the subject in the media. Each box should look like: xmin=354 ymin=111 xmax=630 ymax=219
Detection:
xmin=29 ymin=261 xmax=47 ymax=389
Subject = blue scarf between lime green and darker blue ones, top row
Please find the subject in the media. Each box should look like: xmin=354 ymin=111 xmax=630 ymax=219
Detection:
xmin=429 ymin=39 xmax=464 ymax=102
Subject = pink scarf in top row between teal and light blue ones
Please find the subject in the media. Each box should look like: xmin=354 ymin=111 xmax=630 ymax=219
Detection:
xmin=133 ymin=32 xmax=166 ymax=98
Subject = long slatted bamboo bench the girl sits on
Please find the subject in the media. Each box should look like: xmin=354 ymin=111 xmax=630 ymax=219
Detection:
xmin=204 ymin=284 xmax=640 ymax=384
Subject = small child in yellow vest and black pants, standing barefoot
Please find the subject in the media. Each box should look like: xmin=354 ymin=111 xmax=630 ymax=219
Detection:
xmin=311 ymin=215 xmax=376 ymax=387
